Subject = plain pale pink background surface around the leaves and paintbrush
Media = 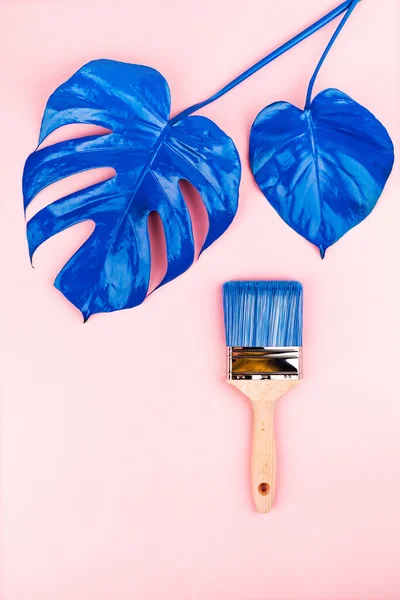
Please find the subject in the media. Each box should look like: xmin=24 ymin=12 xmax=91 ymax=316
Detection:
xmin=0 ymin=0 xmax=400 ymax=600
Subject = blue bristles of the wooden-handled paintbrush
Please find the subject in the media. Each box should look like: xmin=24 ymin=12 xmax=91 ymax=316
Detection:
xmin=223 ymin=281 xmax=303 ymax=347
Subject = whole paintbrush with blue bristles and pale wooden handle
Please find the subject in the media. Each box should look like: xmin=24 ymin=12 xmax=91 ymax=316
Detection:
xmin=223 ymin=281 xmax=303 ymax=513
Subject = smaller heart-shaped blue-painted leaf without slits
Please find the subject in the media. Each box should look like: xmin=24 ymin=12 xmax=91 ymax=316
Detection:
xmin=250 ymin=89 xmax=394 ymax=257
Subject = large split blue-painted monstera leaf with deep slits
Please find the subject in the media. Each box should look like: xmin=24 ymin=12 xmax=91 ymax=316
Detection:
xmin=23 ymin=60 xmax=240 ymax=320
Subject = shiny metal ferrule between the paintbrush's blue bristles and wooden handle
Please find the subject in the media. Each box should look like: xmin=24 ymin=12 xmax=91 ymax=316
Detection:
xmin=227 ymin=346 xmax=302 ymax=379
